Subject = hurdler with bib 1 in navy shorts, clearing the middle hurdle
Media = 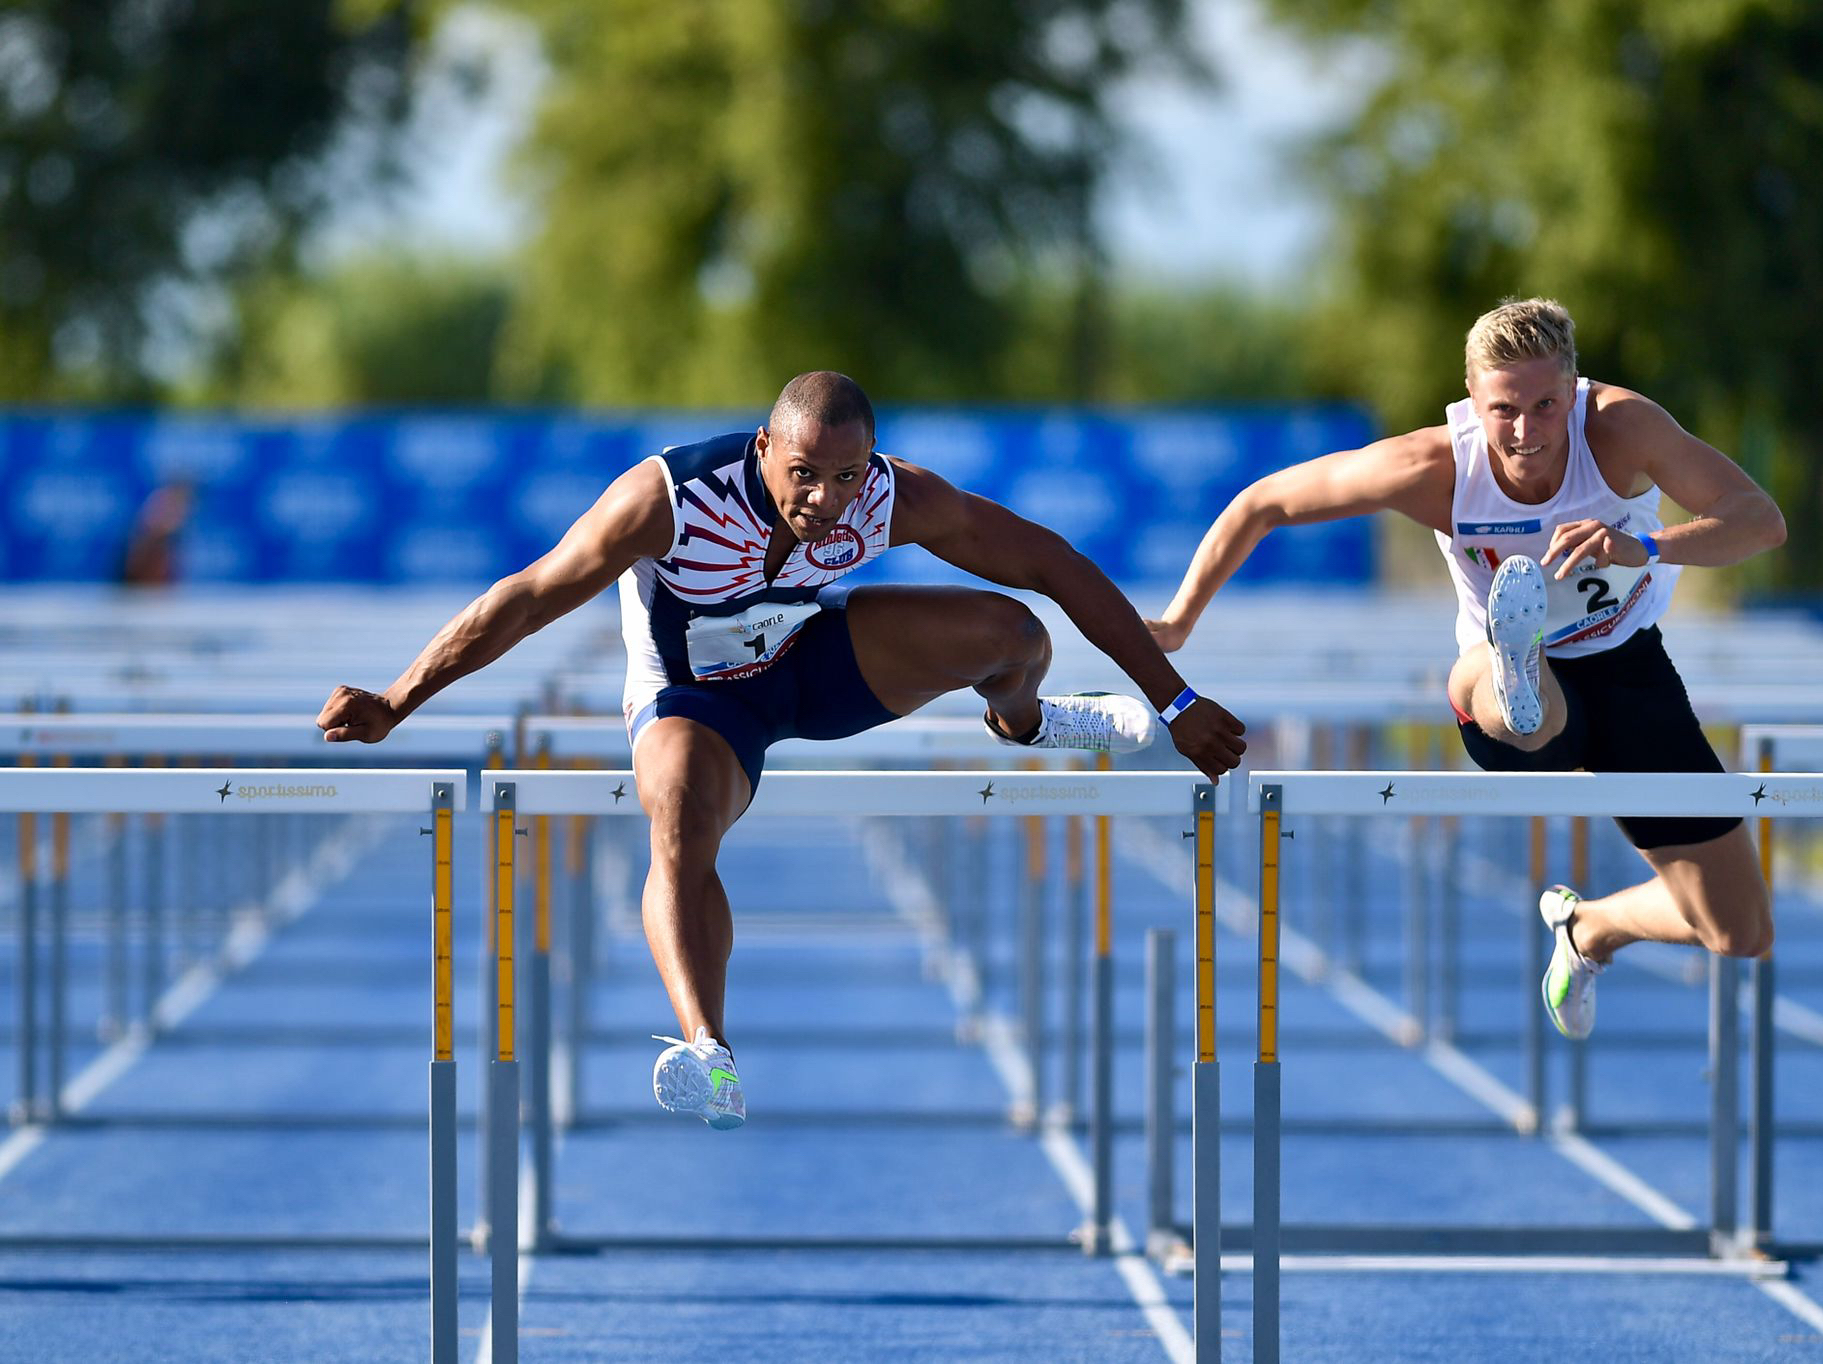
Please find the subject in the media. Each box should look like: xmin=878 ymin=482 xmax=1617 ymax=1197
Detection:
xmin=317 ymin=370 xmax=1245 ymax=1129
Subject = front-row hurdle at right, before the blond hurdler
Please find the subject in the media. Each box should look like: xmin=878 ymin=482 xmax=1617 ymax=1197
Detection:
xmin=1232 ymin=771 xmax=1823 ymax=1360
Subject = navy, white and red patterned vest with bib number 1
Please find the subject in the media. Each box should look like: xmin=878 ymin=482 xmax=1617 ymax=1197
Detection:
xmin=620 ymin=434 xmax=895 ymax=722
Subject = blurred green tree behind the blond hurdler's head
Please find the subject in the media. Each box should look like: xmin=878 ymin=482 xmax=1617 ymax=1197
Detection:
xmin=1272 ymin=0 xmax=1823 ymax=587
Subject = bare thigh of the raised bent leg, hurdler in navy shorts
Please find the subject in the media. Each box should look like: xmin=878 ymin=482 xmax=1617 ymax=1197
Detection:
xmin=846 ymin=587 xmax=1048 ymax=715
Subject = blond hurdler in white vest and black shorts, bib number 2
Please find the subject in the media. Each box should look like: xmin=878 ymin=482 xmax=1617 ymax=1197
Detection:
xmin=1148 ymin=299 xmax=1785 ymax=1038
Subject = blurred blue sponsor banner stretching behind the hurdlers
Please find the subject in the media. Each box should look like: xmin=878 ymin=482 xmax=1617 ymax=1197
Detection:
xmin=0 ymin=407 xmax=1373 ymax=584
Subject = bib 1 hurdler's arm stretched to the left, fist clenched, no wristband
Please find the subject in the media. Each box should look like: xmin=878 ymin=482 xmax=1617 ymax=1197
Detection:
xmin=317 ymin=461 xmax=673 ymax=744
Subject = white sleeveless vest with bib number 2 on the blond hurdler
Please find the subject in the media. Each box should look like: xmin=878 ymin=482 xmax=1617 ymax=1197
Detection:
xmin=1437 ymin=379 xmax=1679 ymax=658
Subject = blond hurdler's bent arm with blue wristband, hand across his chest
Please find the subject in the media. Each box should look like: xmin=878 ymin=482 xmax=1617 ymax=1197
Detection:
xmin=1544 ymin=387 xmax=1785 ymax=578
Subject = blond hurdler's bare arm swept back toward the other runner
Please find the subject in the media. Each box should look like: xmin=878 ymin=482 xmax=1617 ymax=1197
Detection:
xmin=1147 ymin=427 xmax=1455 ymax=651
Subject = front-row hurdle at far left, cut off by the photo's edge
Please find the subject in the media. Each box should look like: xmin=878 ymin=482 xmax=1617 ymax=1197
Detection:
xmin=0 ymin=768 xmax=469 ymax=1364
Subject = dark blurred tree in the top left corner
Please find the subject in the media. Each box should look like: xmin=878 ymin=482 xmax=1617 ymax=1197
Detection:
xmin=0 ymin=0 xmax=430 ymax=401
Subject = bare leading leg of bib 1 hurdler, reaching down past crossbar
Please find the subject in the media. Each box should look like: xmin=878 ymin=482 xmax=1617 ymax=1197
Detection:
xmin=633 ymin=715 xmax=751 ymax=1041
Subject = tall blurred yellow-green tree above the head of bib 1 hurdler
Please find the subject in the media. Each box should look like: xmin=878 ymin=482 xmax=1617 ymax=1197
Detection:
xmin=503 ymin=0 xmax=1185 ymax=405
